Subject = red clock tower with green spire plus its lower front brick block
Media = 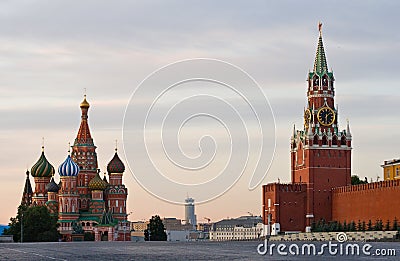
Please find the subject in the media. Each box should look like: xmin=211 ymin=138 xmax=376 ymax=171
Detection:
xmin=262 ymin=23 xmax=352 ymax=235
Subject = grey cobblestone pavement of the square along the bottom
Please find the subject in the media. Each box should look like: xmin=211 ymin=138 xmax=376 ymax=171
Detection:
xmin=0 ymin=241 xmax=400 ymax=260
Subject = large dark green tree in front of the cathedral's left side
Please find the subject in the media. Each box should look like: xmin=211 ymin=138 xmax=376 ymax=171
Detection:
xmin=4 ymin=205 xmax=60 ymax=242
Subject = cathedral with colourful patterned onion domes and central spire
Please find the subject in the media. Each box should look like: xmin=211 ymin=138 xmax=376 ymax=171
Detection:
xmin=21 ymin=95 xmax=130 ymax=241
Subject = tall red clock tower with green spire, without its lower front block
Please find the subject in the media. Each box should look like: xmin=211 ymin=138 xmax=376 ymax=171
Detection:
xmin=291 ymin=23 xmax=352 ymax=230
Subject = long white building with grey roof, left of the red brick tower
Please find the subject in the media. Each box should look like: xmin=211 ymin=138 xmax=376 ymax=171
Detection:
xmin=210 ymin=216 xmax=264 ymax=241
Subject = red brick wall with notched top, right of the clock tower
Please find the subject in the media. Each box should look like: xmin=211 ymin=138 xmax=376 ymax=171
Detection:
xmin=332 ymin=180 xmax=400 ymax=224
